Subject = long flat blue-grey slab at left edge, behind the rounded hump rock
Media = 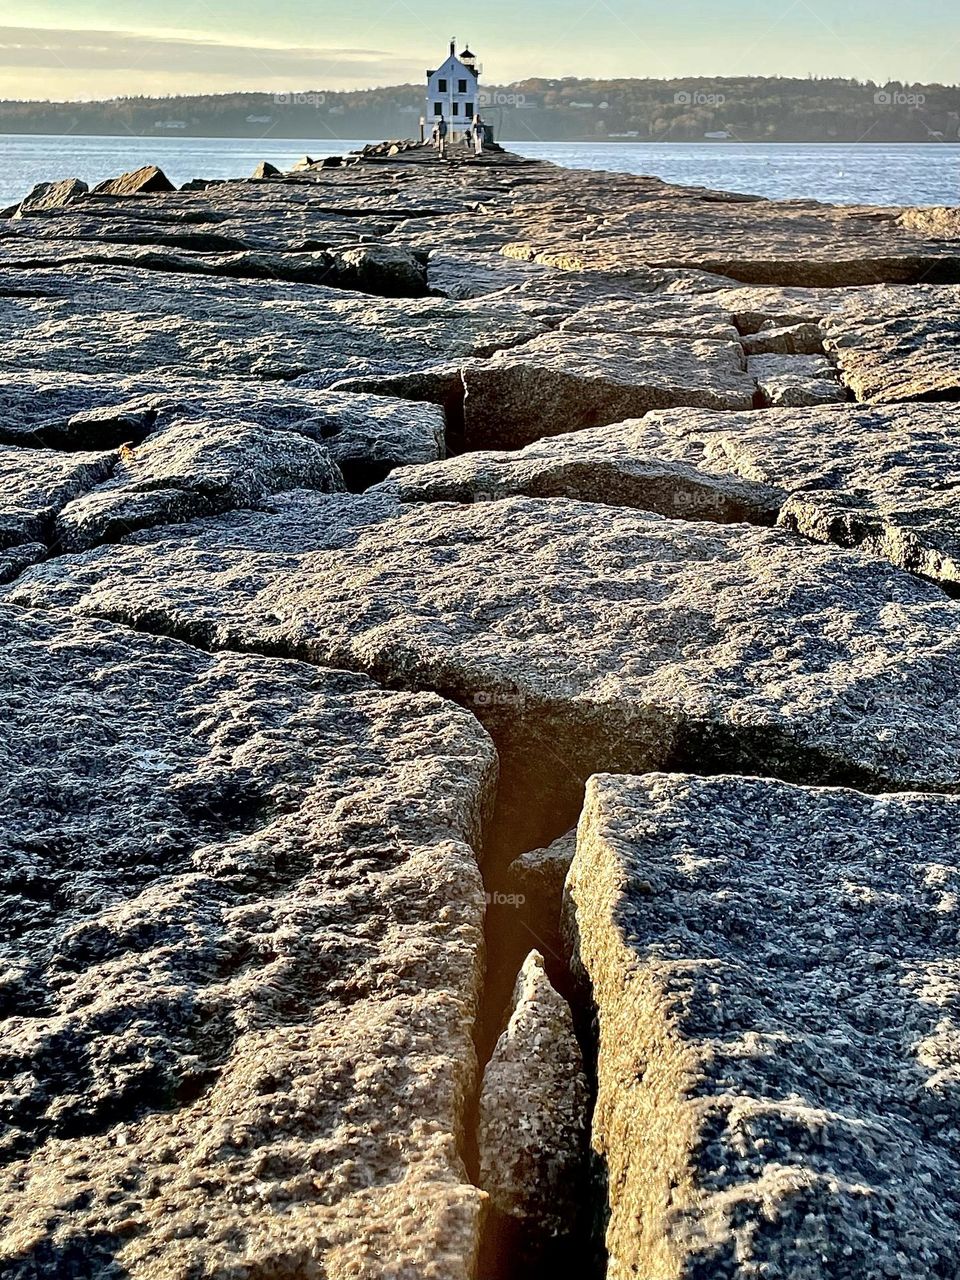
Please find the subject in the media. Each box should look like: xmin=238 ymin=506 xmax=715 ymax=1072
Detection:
xmin=0 ymin=265 xmax=547 ymax=381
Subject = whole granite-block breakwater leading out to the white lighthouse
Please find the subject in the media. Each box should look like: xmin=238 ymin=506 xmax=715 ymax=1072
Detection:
xmin=0 ymin=147 xmax=960 ymax=1280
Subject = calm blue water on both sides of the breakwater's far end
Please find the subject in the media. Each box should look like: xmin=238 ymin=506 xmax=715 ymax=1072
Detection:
xmin=0 ymin=134 xmax=960 ymax=205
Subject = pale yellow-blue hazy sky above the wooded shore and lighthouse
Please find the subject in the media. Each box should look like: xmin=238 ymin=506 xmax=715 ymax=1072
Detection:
xmin=0 ymin=0 xmax=960 ymax=99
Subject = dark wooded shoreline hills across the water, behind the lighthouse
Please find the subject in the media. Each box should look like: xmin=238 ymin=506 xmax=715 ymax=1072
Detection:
xmin=0 ymin=77 xmax=960 ymax=142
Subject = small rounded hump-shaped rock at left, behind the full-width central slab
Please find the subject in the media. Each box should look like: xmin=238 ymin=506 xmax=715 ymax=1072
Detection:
xmin=56 ymin=420 xmax=344 ymax=550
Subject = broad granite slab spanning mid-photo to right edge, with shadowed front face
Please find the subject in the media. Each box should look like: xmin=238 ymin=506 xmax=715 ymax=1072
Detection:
xmin=4 ymin=494 xmax=960 ymax=854
